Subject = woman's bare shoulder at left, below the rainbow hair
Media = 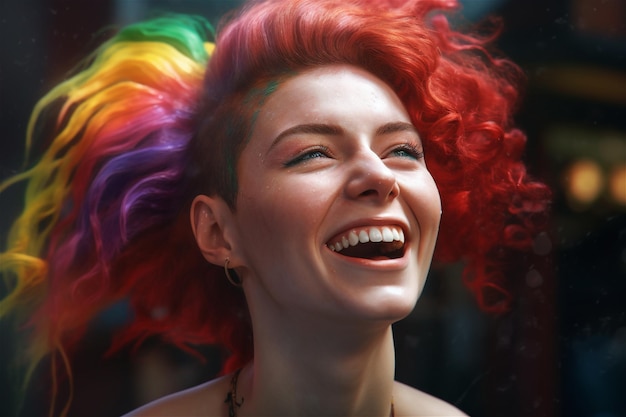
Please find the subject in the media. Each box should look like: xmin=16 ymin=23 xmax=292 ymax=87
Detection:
xmin=123 ymin=375 xmax=231 ymax=417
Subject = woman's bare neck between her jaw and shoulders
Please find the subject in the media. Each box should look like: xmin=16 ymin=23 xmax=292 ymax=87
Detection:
xmin=237 ymin=302 xmax=395 ymax=417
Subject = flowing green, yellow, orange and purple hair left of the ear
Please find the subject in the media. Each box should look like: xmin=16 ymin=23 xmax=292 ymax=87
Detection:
xmin=0 ymin=16 xmax=234 ymax=413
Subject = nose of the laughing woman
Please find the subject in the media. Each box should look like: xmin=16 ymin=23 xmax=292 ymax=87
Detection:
xmin=345 ymin=150 xmax=400 ymax=203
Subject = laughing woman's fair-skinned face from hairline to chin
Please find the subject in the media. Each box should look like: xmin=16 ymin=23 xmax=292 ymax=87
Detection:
xmin=228 ymin=65 xmax=441 ymax=321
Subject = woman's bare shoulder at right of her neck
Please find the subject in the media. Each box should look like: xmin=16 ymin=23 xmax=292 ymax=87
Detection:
xmin=394 ymin=381 xmax=467 ymax=417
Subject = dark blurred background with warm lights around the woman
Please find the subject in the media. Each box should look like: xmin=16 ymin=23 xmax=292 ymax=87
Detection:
xmin=0 ymin=0 xmax=626 ymax=417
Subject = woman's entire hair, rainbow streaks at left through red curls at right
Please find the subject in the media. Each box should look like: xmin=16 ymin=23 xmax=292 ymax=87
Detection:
xmin=0 ymin=0 xmax=549 ymax=412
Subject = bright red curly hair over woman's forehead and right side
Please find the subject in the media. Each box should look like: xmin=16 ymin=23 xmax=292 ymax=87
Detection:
xmin=184 ymin=0 xmax=549 ymax=370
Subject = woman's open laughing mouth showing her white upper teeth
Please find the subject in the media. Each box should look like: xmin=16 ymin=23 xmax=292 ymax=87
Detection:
xmin=326 ymin=226 xmax=404 ymax=260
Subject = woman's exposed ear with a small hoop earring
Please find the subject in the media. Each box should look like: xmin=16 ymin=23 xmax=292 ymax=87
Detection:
xmin=190 ymin=195 xmax=234 ymax=266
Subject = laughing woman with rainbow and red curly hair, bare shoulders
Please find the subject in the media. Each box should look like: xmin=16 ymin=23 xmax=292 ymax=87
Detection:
xmin=0 ymin=0 xmax=548 ymax=416
